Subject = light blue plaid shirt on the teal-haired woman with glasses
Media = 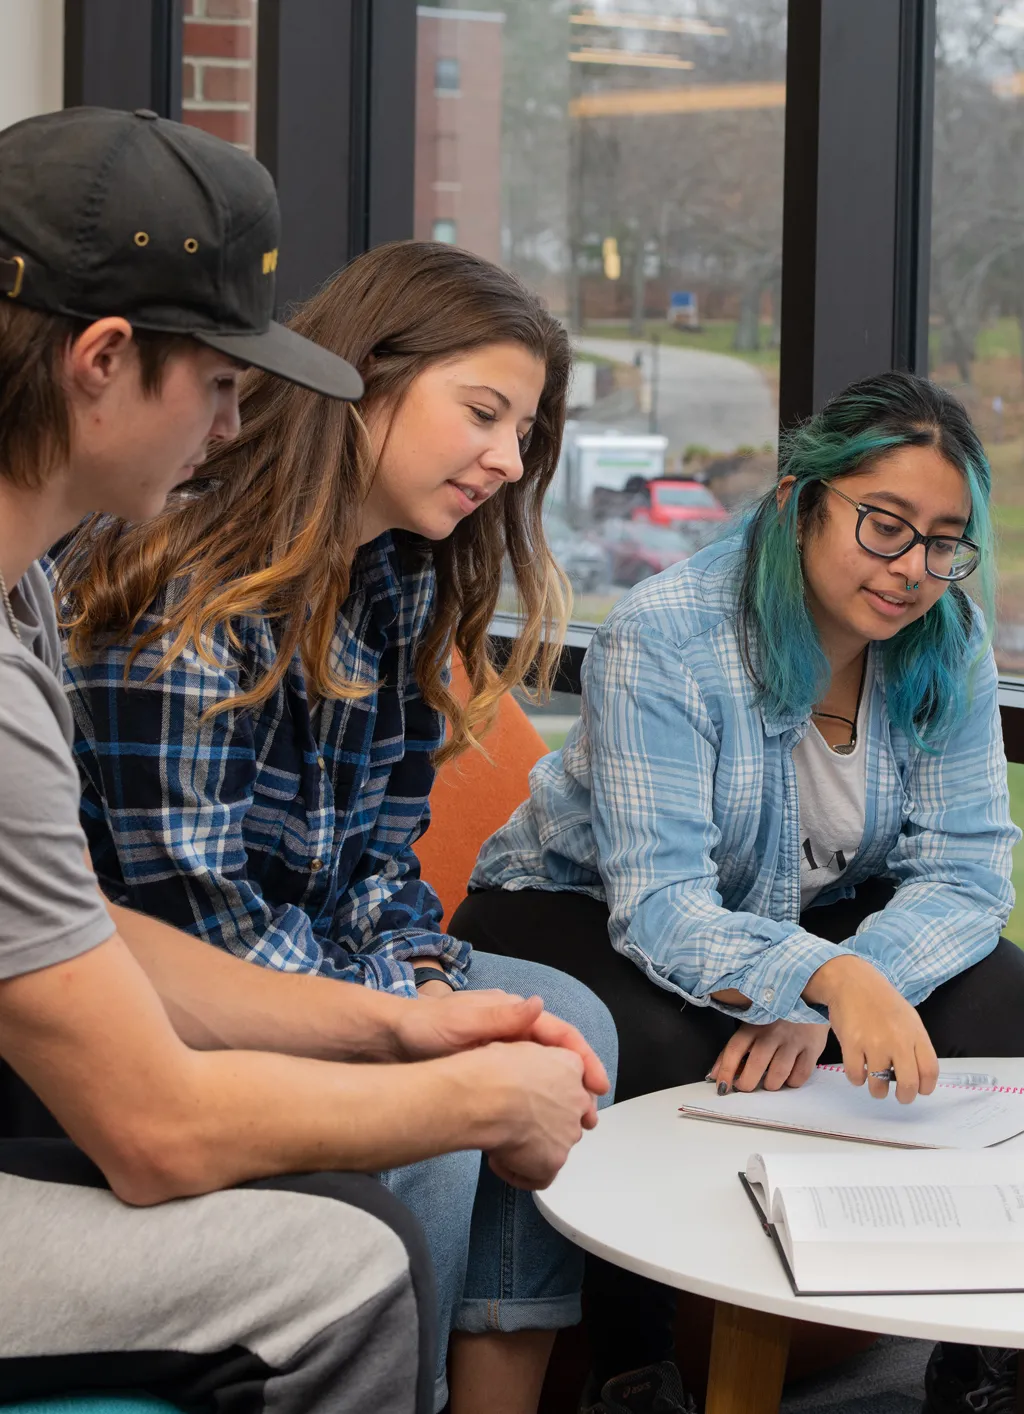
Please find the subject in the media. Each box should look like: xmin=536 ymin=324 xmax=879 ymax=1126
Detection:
xmin=471 ymin=537 xmax=1020 ymax=1025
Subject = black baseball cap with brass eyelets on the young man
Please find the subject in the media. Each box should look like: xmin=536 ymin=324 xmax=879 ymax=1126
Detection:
xmin=0 ymin=107 xmax=363 ymax=400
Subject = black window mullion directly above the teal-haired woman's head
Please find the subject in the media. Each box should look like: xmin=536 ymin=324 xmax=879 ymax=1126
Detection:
xmin=779 ymin=0 xmax=935 ymax=426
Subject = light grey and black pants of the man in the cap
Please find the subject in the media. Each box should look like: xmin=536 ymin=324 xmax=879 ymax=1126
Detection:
xmin=0 ymin=1140 xmax=437 ymax=1414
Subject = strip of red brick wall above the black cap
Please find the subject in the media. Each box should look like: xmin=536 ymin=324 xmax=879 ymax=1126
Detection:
xmin=181 ymin=0 xmax=257 ymax=153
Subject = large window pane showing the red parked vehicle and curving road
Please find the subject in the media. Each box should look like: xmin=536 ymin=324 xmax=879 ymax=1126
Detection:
xmin=416 ymin=0 xmax=786 ymax=681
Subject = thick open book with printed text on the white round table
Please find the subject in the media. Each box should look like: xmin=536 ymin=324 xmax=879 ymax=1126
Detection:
xmin=740 ymin=1150 xmax=1024 ymax=1297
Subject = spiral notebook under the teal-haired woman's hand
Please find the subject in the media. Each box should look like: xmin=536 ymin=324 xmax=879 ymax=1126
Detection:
xmin=679 ymin=1061 xmax=1024 ymax=1150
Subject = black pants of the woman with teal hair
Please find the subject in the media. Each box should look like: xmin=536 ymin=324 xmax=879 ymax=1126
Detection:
xmin=450 ymin=880 xmax=1024 ymax=1380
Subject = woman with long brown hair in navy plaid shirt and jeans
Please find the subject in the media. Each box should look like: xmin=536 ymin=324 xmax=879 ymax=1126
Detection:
xmin=51 ymin=243 xmax=615 ymax=1414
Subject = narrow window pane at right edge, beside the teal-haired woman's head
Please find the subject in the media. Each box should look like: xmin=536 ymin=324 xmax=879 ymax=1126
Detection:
xmin=929 ymin=0 xmax=1024 ymax=674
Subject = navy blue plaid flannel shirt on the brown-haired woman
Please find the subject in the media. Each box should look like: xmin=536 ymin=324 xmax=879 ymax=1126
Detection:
xmin=65 ymin=534 xmax=470 ymax=995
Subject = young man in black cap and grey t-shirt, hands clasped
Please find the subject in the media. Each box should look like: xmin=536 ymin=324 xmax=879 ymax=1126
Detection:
xmin=0 ymin=109 xmax=607 ymax=1414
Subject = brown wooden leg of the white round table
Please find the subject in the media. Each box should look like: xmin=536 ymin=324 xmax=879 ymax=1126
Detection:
xmin=704 ymin=1301 xmax=791 ymax=1414
